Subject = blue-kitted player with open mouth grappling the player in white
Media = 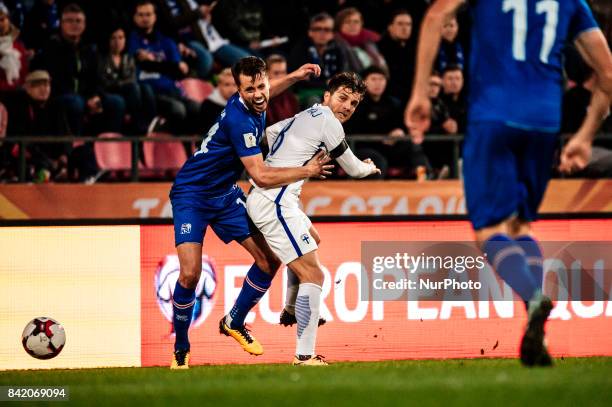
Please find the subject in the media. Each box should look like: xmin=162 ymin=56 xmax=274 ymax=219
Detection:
xmin=170 ymin=57 xmax=333 ymax=369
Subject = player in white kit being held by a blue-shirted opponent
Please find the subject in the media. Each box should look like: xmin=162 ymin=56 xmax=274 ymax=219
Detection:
xmin=247 ymin=72 xmax=380 ymax=365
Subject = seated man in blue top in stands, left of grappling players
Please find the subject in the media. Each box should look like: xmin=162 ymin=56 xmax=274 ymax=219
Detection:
xmin=128 ymin=0 xmax=200 ymax=134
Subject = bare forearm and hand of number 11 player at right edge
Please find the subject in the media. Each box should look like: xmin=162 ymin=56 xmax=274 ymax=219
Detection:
xmin=559 ymin=87 xmax=610 ymax=174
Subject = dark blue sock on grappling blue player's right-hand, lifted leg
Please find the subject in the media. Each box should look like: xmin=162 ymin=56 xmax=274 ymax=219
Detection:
xmin=229 ymin=263 xmax=273 ymax=329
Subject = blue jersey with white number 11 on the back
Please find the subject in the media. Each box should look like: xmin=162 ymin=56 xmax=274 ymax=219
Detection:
xmin=468 ymin=0 xmax=597 ymax=132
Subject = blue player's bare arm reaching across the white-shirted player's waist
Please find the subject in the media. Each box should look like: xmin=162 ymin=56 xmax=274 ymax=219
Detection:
xmin=240 ymin=151 xmax=334 ymax=188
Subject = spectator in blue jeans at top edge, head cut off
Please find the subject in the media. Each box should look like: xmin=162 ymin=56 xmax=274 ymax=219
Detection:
xmin=159 ymin=0 xmax=250 ymax=78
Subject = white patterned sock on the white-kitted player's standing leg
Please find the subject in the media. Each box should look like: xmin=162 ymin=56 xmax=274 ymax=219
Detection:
xmin=295 ymin=283 xmax=321 ymax=356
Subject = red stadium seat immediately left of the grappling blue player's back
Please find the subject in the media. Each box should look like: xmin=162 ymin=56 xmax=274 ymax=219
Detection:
xmin=142 ymin=133 xmax=187 ymax=172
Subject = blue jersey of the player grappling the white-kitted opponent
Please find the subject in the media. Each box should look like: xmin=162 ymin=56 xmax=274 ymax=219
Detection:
xmin=170 ymin=93 xmax=266 ymax=197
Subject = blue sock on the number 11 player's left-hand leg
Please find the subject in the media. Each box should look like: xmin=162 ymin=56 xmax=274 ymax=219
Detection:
xmin=482 ymin=234 xmax=541 ymax=304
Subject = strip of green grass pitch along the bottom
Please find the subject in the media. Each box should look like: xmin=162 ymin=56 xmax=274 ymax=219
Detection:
xmin=0 ymin=358 xmax=612 ymax=407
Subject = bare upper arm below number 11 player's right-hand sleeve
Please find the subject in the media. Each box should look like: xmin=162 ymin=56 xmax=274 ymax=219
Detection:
xmin=575 ymin=29 xmax=612 ymax=103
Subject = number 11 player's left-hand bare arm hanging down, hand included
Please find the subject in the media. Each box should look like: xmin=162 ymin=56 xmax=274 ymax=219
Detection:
xmin=404 ymin=0 xmax=464 ymax=136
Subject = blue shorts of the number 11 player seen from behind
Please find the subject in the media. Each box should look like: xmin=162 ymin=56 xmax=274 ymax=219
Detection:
xmin=463 ymin=122 xmax=559 ymax=230
